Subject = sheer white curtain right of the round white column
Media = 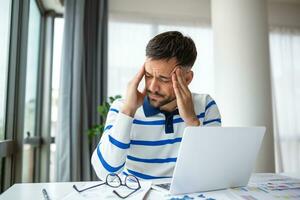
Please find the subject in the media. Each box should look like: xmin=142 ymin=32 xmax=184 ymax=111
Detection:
xmin=270 ymin=28 xmax=300 ymax=173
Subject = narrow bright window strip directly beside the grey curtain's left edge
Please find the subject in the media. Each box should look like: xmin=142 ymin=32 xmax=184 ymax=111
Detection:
xmin=49 ymin=18 xmax=64 ymax=182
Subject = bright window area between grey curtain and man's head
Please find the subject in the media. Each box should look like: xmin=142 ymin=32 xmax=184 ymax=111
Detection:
xmin=107 ymin=22 xmax=154 ymax=96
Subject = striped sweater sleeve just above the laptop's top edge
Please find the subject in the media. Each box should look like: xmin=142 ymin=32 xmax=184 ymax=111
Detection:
xmin=203 ymin=95 xmax=222 ymax=126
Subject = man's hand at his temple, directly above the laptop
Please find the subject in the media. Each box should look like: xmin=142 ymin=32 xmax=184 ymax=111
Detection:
xmin=172 ymin=67 xmax=200 ymax=126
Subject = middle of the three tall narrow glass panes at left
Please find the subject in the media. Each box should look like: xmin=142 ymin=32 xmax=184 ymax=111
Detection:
xmin=22 ymin=0 xmax=41 ymax=182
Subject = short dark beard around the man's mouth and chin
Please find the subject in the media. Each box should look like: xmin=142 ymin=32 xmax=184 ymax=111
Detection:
xmin=147 ymin=90 xmax=176 ymax=108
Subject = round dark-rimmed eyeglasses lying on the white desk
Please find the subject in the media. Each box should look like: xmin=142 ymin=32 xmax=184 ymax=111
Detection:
xmin=73 ymin=173 xmax=141 ymax=199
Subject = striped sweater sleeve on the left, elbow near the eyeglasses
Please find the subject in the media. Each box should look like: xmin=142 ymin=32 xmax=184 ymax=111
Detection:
xmin=91 ymin=99 xmax=133 ymax=180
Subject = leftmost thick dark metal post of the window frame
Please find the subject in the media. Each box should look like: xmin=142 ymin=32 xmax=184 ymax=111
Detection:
xmin=1 ymin=0 xmax=29 ymax=191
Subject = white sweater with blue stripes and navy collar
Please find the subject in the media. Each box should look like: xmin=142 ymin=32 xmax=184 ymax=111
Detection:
xmin=91 ymin=93 xmax=221 ymax=180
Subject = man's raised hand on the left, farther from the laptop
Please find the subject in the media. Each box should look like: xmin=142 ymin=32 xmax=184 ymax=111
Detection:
xmin=122 ymin=64 xmax=146 ymax=117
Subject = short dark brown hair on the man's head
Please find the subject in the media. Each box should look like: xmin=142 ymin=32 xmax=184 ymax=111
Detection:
xmin=146 ymin=31 xmax=197 ymax=67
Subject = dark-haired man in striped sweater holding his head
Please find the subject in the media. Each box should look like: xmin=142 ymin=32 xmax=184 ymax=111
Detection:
xmin=92 ymin=31 xmax=221 ymax=180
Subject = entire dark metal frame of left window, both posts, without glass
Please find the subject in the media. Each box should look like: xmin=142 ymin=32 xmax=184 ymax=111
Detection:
xmin=0 ymin=0 xmax=62 ymax=193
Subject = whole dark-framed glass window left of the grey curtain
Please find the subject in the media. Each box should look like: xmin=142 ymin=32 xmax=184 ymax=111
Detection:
xmin=0 ymin=0 xmax=63 ymax=188
